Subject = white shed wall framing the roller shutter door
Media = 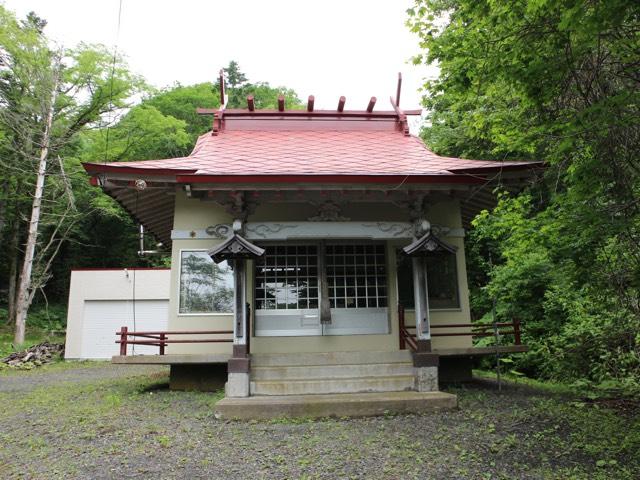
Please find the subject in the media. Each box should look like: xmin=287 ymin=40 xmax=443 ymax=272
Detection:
xmin=65 ymin=268 xmax=171 ymax=359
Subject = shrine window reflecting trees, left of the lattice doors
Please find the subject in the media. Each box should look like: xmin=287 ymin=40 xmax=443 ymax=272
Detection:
xmin=178 ymin=250 xmax=234 ymax=314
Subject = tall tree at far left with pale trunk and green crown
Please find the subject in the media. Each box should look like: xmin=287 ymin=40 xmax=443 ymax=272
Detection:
xmin=0 ymin=7 xmax=142 ymax=343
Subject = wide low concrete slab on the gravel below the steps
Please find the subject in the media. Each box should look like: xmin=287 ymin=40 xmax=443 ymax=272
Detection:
xmin=215 ymin=392 xmax=458 ymax=420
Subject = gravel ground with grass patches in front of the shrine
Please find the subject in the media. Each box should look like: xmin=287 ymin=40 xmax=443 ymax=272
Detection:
xmin=0 ymin=365 xmax=640 ymax=479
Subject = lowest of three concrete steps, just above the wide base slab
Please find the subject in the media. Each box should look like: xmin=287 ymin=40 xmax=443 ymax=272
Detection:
xmin=250 ymin=375 xmax=415 ymax=395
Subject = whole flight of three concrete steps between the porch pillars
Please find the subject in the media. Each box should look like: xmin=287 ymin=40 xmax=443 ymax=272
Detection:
xmin=250 ymin=350 xmax=415 ymax=395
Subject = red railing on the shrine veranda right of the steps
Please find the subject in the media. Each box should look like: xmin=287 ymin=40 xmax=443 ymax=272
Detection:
xmin=398 ymin=305 xmax=522 ymax=350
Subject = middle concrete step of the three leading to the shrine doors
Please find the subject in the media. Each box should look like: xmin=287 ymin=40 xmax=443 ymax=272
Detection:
xmin=251 ymin=362 xmax=413 ymax=381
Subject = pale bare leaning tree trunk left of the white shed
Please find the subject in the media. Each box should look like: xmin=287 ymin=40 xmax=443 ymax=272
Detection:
xmin=14 ymin=60 xmax=60 ymax=344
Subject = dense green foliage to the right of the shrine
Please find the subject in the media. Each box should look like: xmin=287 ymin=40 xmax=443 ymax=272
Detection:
xmin=408 ymin=0 xmax=640 ymax=390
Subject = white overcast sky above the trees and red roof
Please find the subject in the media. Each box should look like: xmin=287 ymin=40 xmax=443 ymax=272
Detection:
xmin=0 ymin=0 xmax=436 ymax=116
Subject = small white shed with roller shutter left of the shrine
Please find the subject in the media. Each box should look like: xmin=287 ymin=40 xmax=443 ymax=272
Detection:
xmin=65 ymin=268 xmax=171 ymax=359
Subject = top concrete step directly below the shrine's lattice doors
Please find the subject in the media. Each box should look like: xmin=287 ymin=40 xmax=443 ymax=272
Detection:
xmin=251 ymin=350 xmax=411 ymax=367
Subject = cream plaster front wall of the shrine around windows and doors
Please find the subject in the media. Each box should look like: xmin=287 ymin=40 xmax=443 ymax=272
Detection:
xmin=167 ymin=192 xmax=471 ymax=353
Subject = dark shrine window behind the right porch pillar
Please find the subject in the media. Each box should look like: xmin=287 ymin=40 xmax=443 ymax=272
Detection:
xmin=396 ymin=251 xmax=460 ymax=310
